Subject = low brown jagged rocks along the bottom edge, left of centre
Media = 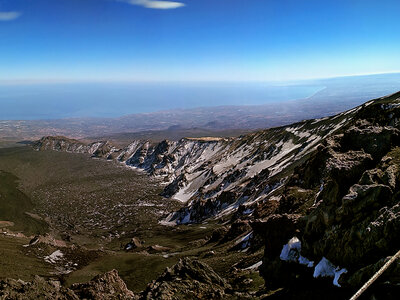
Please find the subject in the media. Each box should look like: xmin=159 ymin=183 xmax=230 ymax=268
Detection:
xmin=0 ymin=258 xmax=251 ymax=300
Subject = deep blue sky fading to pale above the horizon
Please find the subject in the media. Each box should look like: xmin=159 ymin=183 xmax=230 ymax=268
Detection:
xmin=0 ymin=0 xmax=400 ymax=81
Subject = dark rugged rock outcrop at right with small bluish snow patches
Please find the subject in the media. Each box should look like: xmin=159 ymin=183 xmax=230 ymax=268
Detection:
xmin=252 ymin=94 xmax=400 ymax=299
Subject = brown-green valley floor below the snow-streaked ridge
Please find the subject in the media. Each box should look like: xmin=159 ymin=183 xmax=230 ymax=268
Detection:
xmin=0 ymin=147 xmax=263 ymax=292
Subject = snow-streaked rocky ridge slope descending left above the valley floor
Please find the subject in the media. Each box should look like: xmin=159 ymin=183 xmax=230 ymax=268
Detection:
xmin=34 ymin=93 xmax=362 ymax=223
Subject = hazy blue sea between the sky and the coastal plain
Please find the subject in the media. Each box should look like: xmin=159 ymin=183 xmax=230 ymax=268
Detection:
xmin=0 ymin=82 xmax=324 ymax=120
